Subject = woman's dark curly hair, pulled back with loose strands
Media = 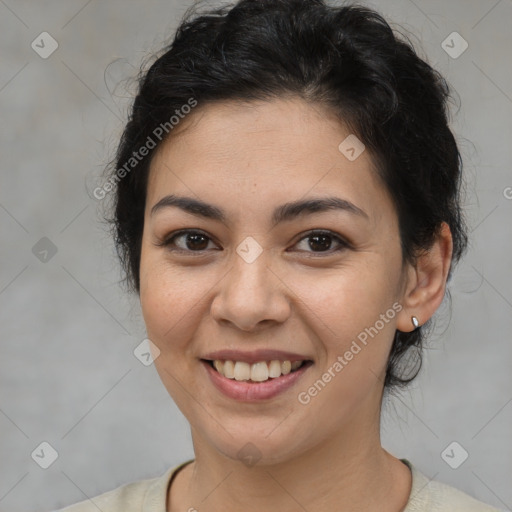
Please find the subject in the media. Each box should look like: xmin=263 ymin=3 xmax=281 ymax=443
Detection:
xmin=99 ymin=0 xmax=467 ymax=389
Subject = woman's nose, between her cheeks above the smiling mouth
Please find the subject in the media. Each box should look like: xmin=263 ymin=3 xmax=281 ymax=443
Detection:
xmin=211 ymin=251 xmax=290 ymax=331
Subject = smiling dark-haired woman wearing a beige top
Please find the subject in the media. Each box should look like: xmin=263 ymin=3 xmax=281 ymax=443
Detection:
xmin=56 ymin=0 xmax=496 ymax=512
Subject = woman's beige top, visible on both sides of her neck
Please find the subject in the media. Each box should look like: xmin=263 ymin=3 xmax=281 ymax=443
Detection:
xmin=55 ymin=459 xmax=499 ymax=512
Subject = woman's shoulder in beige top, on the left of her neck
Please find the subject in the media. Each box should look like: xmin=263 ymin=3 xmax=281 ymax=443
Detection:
xmin=53 ymin=463 xmax=186 ymax=512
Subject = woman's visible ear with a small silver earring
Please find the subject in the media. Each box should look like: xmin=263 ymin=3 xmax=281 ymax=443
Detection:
xmin=396 ymin=222 xmax=453 ymax=332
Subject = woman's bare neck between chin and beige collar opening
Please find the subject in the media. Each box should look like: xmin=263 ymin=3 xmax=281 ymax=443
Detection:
xmin=169 ymin=410 xmax=411 ymax=512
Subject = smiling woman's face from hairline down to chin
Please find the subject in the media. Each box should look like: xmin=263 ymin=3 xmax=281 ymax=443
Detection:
xmin=140 ymin=99 xmax=412 ymax=463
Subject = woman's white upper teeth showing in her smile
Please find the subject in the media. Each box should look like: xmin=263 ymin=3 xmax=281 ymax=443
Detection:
xmin=213 ymin=359 xmax=304 ymax=382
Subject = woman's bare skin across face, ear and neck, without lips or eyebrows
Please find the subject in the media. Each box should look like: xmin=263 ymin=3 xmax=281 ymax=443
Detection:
xmin=140 ymin=98 xmax=452 ymax=512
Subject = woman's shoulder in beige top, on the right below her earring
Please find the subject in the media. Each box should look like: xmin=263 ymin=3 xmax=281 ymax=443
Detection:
xmin=404 ymin=461 xmax=500 ymax=512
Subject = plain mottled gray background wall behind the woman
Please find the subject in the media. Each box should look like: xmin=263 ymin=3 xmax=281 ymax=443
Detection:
xmin=0 ymin=0 xmax=512 ymax=512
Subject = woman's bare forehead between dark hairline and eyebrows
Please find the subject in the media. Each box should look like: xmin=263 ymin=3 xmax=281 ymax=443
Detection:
xmin=147 ymin=99 xmax=392 ymax=224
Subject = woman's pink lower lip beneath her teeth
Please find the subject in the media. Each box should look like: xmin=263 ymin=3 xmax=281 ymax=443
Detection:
xmin=201 ymin=361 xmax=312 ymax=402
